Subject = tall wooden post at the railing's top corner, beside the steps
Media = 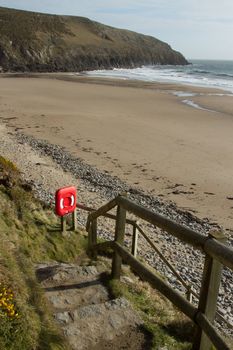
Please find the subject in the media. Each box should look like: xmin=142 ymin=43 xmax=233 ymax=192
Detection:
xmin=112 ymin=194 xmax=126 ymax=280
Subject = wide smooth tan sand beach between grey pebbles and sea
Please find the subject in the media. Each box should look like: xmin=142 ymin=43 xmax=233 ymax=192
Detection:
xmin=0 ymin=75 xmax=233 ymax=230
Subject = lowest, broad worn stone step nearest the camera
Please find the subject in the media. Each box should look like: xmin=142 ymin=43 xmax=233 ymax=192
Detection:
xmin=54 ymin=298 xmax=143 ymax=350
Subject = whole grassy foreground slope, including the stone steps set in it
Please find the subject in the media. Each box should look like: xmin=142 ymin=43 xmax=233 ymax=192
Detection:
xmin=0 ymin=156 xmax=191 ymax=350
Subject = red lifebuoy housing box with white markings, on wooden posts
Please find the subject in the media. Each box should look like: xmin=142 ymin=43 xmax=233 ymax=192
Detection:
xmin=55 ymin=186 xmax=77 ymax=216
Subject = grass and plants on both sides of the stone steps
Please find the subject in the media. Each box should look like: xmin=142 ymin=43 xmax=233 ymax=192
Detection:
xmin=0 ymin=157 xmax=206 ymax=350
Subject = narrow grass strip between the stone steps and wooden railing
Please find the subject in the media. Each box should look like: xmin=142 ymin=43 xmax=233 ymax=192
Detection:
xmin=108 ymin=272 xmax=193 ymax=350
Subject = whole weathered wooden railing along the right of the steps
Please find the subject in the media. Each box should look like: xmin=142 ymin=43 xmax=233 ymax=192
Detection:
xmin=78 ymin=195 xmax=233 ymax=350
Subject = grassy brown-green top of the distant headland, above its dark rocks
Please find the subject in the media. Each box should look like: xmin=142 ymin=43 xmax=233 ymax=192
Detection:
xmin=0 ymin=7 xmax=168 ymax=46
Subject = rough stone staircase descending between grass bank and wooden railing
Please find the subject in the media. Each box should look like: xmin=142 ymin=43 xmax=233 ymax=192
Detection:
xmin=37 ymin=263 xmax=150 ymax=350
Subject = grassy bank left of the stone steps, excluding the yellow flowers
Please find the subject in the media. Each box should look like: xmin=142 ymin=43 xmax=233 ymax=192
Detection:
xmin=0 ymin=157 xmax=87 ymax=350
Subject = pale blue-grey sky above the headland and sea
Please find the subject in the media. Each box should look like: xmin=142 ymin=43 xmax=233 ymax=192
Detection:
xmin=0 ymin=0 xmax=233 ymax=60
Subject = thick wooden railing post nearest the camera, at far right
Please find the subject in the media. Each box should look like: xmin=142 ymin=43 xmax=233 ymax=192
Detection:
xmin=192 ymin=231 xmax=226 ymax=350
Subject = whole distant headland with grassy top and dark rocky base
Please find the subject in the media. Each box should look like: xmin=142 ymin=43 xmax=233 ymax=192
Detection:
xmin=0 ymin=7 xmax=188 ymax=72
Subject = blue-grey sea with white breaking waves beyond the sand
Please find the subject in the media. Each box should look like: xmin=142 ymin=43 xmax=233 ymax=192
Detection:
xmin=85 ymin=59 xmax=233 ymax=93
